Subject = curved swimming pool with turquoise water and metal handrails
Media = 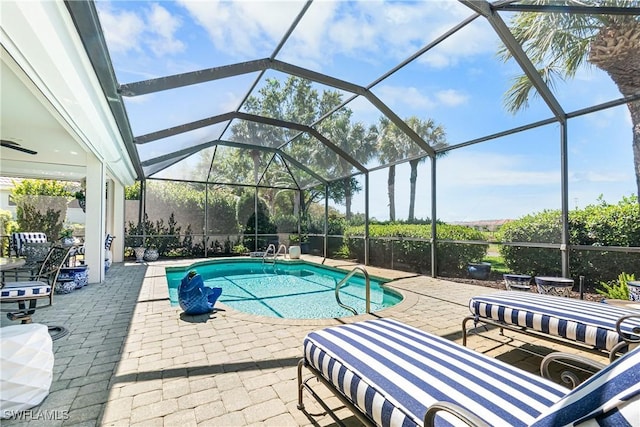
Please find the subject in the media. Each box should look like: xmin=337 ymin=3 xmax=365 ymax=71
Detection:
xmin=166 ymin=259 xmax=402 ymax=319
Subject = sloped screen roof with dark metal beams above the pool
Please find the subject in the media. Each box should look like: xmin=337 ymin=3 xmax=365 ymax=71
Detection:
xmin=68 ymin=0 xmax=638 ymax=188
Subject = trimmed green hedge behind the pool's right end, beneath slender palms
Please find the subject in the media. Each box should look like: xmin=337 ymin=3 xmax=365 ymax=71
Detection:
xmin=344 ymin=224 xmax=489 ymax=275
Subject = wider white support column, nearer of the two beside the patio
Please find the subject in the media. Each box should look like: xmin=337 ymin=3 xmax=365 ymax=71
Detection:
xmin=84 ymin=154 xmax=106 ymax=283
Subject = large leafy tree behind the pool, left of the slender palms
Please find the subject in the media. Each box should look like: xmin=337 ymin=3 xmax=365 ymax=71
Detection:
xmin=229 ymin=76 xmax=375 ymax=221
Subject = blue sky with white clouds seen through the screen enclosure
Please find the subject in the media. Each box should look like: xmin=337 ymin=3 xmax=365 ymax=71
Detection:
xmin=97 ymin=0 xmax=636 ymax=222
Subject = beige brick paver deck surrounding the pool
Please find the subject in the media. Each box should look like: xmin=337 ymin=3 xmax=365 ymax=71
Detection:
xmin=1 ymin=257 xmax=604 ymax=427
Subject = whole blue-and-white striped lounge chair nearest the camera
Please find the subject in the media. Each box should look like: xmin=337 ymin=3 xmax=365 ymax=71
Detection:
xmin=298 ymin=319 xmax=640 ymax=427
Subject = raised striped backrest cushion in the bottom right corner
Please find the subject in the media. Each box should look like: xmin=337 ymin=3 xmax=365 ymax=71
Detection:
xmin=533 ymin=347 xmax=640 ymax=427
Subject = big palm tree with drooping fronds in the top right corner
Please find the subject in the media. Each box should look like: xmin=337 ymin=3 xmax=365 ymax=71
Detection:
xmin=498 ymin=0 xmax=640 ymax=200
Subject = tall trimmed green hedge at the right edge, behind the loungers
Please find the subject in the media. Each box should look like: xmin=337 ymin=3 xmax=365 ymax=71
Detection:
xmin=500 ymin=196 xmax=640 ymax=284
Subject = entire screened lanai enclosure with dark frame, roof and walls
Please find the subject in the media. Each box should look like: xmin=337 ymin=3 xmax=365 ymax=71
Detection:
xmin=67 ymin=0 xmax=640 ymax=288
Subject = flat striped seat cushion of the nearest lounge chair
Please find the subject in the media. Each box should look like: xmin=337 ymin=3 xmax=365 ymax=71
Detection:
xmin=304 ymin=319 xmax=568 ymax=426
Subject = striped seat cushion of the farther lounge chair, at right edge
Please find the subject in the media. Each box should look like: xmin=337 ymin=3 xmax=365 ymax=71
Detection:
xmin=469 ymin=291 xmax=640 ymax=351
